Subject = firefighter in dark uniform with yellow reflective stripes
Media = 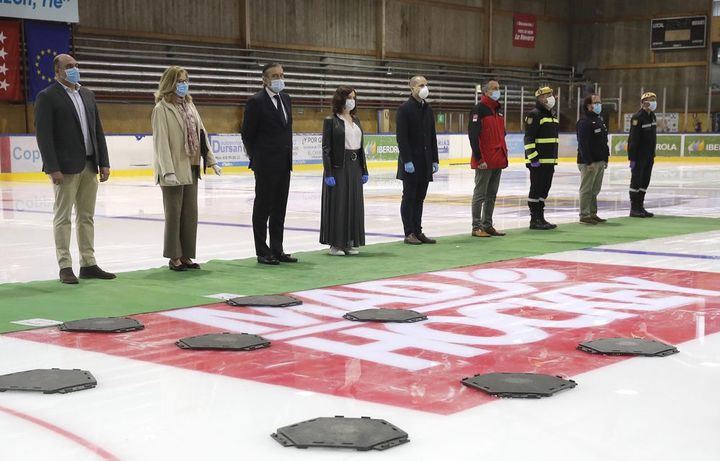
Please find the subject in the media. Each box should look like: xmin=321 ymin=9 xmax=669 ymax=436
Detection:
xmin=525 ymin=87 xmax=560 ymax=230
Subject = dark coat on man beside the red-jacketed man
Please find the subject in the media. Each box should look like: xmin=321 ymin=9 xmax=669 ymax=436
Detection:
xmin=395 ymin=96 xmax=438 ymax=181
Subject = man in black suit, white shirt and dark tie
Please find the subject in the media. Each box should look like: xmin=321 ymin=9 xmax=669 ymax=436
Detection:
xmin=241 ymin=63 xmax=297 ymax=265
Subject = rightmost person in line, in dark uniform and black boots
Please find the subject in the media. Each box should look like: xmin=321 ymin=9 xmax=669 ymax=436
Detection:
xmin=628 ymin=92 xmax=657 ymax=218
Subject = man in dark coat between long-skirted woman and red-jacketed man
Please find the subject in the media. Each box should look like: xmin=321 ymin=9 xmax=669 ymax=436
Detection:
xmin=395 ymin=75 xmax=439 ymax=245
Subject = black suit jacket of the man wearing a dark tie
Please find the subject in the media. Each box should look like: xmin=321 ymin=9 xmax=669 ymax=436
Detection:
xmin=240 ymin=88 xmax=292 ymax=173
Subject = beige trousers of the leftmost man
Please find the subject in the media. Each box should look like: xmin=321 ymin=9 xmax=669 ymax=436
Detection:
xmin=53 ymin=161 xmax=98 ymax=269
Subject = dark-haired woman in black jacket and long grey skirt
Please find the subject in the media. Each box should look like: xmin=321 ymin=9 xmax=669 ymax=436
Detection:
xmin=320 ymin=86 xmax=368 ymax=256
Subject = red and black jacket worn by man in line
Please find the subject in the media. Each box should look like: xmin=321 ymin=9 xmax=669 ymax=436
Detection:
xmin=468 ymin=95 xmax=508 ymax=170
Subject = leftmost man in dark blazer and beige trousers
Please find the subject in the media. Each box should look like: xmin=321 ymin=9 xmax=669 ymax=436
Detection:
xmin=35 ymin=54 xmax=115 ymax=284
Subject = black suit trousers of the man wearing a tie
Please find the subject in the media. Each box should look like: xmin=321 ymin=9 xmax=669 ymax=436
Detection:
xmin=253 ymin=170 xmax=290 ymax=256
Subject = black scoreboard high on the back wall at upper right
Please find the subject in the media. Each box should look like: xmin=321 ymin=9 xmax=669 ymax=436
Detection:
xmin=650 ymin=16 xmax=707 ymax=51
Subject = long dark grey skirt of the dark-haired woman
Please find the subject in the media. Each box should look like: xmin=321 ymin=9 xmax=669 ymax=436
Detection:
xmin=320 ymin=150 xmax=365 ymax=248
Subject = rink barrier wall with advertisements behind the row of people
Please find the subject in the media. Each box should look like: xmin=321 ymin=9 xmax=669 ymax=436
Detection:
xmin=0 ymin=133 xmax=720 ymax=179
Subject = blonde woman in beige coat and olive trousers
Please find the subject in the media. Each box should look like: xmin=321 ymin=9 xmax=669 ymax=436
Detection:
xmin=152 ymin=66 xmax=221 ymax=271
